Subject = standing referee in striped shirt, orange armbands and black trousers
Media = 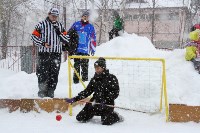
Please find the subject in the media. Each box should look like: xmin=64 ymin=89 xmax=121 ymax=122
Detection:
xmin=31 ymin=8 xmax=69 ymax=98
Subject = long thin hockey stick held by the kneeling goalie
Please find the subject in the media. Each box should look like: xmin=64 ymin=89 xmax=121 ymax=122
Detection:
xmin=78 ymin=100 xmax=160 ymax=115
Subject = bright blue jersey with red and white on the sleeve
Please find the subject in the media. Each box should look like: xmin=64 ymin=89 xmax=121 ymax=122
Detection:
xmin=71 ymin=21 xmax=96 ymax=54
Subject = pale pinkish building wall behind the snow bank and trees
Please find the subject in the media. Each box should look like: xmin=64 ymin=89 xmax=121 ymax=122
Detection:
xmin=96 ymin=7 xmax=189 ymax=48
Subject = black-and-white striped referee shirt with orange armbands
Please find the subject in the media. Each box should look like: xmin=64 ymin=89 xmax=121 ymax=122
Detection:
xmin=31 ymin=17 xmax=69 ymax=53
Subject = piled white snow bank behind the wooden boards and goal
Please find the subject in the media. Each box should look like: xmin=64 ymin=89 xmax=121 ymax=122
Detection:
xmin=0 ymin=33 xmax=200 ymax=105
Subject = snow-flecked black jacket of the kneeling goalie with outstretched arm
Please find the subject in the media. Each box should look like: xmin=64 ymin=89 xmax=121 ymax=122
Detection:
xmin=74 ymin=69 xmax=119 ymax=105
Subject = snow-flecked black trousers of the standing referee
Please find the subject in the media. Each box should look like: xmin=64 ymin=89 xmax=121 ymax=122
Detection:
xmin=36 ymin=52 xmax=61 ymax=98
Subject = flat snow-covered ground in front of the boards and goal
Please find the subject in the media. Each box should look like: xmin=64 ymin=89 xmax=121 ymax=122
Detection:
xmin=0 ymin=107 xmax=200 ymax=133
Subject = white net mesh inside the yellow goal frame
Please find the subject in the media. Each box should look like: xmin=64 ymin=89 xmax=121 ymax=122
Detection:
xmin=69 ymin=59 xmax=163 ymax=112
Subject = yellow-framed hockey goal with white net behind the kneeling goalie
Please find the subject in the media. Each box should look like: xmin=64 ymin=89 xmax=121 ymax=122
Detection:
xmin=68 ymin=56 xmax=168 ymax=120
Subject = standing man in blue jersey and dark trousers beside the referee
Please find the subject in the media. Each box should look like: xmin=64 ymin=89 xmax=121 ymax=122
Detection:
xmin=71 ymin=11 xmax=96 ymax=84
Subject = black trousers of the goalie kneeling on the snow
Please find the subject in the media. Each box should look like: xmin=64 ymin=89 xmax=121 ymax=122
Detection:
xmin=76 ymin=103 xmax=120 ymax=125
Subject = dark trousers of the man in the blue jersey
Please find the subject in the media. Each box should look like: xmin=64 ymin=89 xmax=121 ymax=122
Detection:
xmin=73 ymin=53 xmax=89 ymax=83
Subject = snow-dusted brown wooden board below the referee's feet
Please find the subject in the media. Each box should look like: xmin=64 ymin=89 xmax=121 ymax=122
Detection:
xmin=0 ymin=98 xmax=68 ymax=113
